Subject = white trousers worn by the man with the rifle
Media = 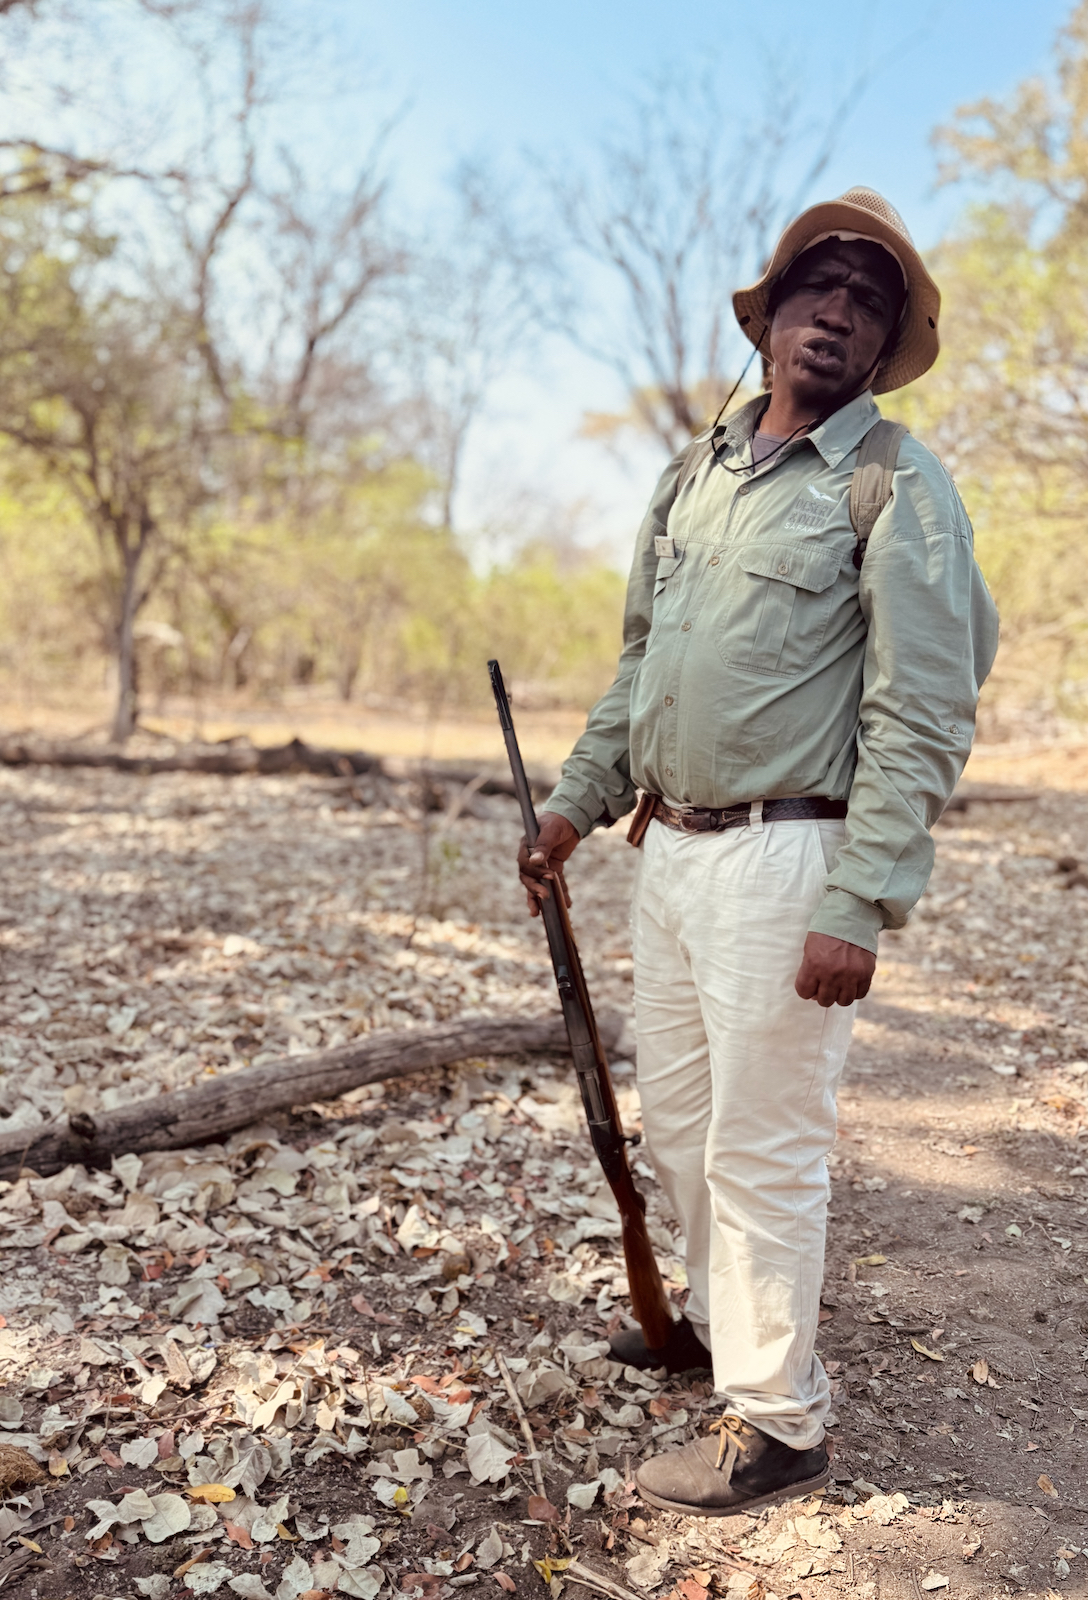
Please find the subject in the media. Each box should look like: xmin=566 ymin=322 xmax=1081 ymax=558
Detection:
xmin=632 ymin=821 xmax=854 ymax=1450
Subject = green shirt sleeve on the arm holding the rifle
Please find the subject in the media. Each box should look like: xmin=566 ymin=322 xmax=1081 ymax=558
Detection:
xmin=544 ymin=445 xmax=691 ymax=838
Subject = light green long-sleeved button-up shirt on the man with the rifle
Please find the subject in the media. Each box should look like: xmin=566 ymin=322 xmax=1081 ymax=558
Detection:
xmin=547 ymin=392 xmax=997 ymax=950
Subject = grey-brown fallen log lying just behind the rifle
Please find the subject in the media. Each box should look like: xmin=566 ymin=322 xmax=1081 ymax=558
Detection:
xmin=0 ymin=1014 xmax=622 ymax=1181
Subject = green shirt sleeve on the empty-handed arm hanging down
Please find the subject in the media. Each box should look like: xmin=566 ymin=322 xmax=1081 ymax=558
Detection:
xmin=810 ymin=440 xmax=997 ymax=952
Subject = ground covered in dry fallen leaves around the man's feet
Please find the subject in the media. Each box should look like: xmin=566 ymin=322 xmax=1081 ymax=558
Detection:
xmin=0 ymin=752 xmax=1088 ymax=1600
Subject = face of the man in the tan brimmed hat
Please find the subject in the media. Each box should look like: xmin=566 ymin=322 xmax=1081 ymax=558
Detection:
xmin=770 ymin=238 xmax=902 ymax=411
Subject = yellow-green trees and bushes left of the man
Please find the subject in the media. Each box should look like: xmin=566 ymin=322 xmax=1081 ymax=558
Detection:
xmin=0 ymin=180 xmax=622 ymax=720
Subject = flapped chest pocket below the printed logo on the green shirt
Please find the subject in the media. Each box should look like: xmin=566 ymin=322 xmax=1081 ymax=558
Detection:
xmin=717 ymin=542 xmax=842 ymax=678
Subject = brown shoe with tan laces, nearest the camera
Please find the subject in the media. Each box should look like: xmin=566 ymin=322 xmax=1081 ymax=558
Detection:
xmin=635 ymin=1411 xmax=830 ymax=1517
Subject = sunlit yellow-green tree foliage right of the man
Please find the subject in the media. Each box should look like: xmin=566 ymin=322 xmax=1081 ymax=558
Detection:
xmin=888 ymin=3 xmax=1088 ymax=717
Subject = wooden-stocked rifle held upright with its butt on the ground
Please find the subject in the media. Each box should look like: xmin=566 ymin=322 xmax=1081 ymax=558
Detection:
xmin=488 ymin=661 xmax=672 ymax=1350
